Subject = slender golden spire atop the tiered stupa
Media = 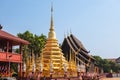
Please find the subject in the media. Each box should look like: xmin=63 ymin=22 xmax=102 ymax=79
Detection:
xmin=48 ymin=6 xmax=56 ymax=39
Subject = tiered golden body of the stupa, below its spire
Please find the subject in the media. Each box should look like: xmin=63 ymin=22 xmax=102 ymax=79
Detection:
xmin=41 ymin=39 xmax=68 ymax=77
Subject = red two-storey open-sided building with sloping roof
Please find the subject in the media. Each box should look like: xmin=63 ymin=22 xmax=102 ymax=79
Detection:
xmin=0 ymin=25 xmax=29 ymax=77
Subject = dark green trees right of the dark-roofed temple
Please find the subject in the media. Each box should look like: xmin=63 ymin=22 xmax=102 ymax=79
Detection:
xmin=93 ymin=56 xmax=120 ymax=72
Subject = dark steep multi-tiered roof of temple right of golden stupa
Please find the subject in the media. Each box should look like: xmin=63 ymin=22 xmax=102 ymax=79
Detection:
xmin=61 ymin=34 xmax=94 ymax=61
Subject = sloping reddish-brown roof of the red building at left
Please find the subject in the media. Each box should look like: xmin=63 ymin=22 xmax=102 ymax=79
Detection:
xmin=0 ymin=30 xmax=29 ymax=45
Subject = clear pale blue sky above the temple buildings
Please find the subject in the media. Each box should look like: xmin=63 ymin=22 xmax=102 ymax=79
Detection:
xmin=0 ymin=0 xmax=120 ymax=58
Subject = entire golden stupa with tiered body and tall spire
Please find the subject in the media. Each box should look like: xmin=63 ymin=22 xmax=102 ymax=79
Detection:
xmin=40 ymin=8 xmax=68 ymax=77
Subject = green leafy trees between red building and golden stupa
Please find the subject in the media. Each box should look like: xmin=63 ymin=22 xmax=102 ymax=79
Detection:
xmin=17 ymin=31 xmax=46 ymax=61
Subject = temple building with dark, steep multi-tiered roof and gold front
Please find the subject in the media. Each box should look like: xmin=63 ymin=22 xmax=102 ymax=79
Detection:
xmin=61 ymin=34 xmax=95 ymax=72
